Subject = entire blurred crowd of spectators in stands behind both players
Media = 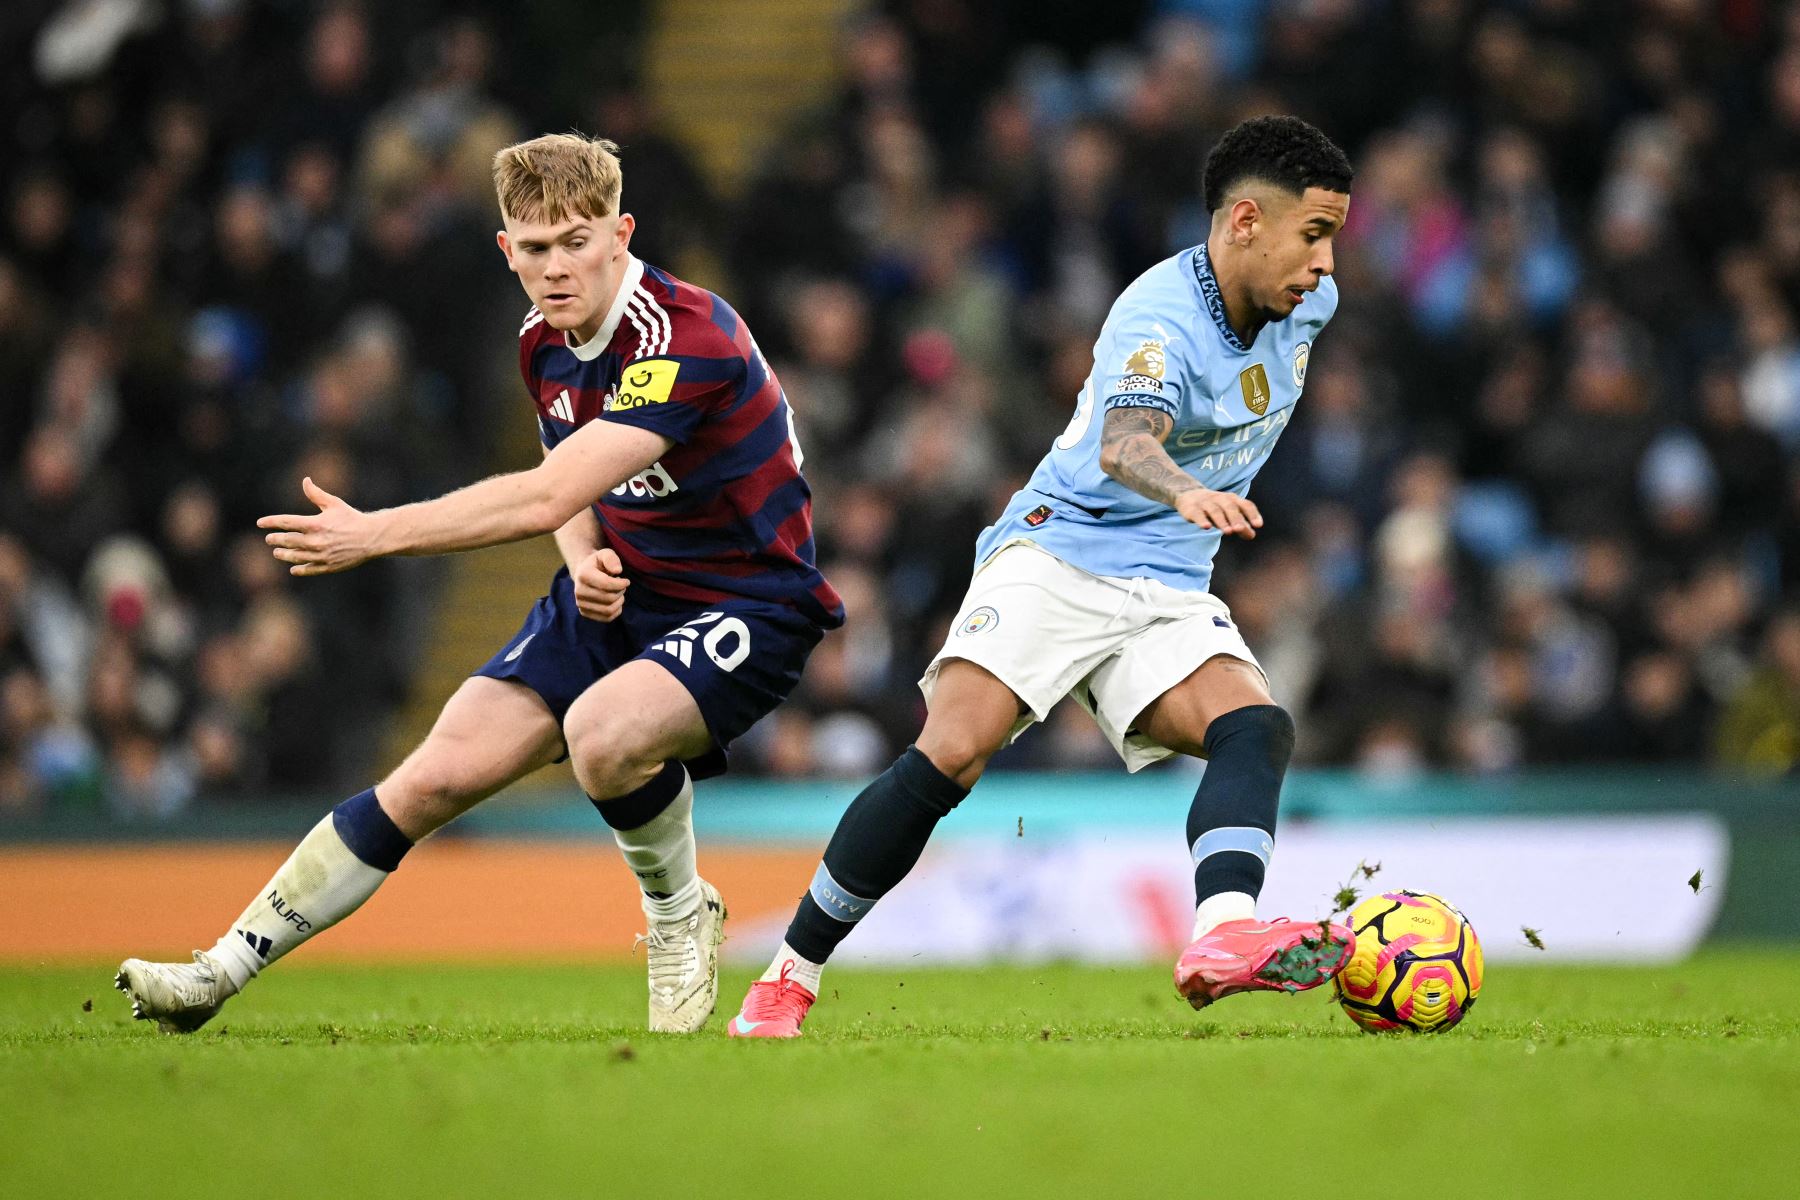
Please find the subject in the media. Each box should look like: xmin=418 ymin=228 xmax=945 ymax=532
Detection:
xmin=0 ymin=0 xmax=1800 ymax=817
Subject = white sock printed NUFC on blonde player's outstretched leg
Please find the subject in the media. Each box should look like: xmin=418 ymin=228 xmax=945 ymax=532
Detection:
xmin=207 ymin=813 xmax=389 ymax=991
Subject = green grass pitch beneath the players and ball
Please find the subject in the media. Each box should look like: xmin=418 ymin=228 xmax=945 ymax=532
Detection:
xmin=0 ymin=948 xmax=1800 ymax=1200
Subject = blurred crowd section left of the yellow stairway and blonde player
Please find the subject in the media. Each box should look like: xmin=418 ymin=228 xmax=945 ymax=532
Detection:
xmin=0 ymin=0 xmax=590 ymax=817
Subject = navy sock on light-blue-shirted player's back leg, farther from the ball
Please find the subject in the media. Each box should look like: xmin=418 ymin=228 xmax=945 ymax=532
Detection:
xmin=787 ymin=747 xmax=968 ymax=963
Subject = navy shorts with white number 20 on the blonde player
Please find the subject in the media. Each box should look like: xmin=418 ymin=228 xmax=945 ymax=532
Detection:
xmin=475 ymin=567 xmax=824 ymax=779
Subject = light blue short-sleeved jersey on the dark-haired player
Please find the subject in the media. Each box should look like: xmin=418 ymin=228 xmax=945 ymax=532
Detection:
xmin=976 ymin=243 xmax=1337 ymax=592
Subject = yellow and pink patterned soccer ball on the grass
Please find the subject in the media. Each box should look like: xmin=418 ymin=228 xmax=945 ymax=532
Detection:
xmin=1334 ymin=892 xmax=1481 ymax=1033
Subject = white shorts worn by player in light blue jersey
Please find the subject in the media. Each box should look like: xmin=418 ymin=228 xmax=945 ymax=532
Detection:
xmin=918 ymin=540 xmax=1269 ymax=772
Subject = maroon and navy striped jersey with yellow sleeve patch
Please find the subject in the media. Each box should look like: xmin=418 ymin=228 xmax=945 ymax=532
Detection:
xmin=518 ymin=257 xmax=844 ymax=628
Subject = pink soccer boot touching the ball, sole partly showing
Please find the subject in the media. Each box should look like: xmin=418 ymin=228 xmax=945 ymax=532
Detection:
xmin=1175 ymin=918 xmax=1355 ymax=1007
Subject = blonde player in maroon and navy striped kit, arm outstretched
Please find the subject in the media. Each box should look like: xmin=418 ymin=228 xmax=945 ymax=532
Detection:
xmin=117 ymin=133 xmax=844 ymax=1033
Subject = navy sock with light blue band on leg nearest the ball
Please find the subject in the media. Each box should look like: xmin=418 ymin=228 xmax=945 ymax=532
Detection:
xmin=1188 ymin=703 xmax=1294 ymax=903
